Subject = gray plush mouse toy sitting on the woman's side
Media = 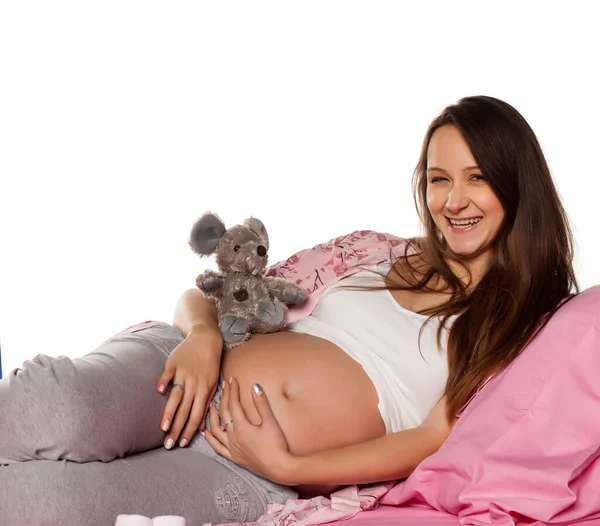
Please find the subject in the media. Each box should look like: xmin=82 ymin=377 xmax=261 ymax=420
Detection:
xmin=189 ymin=212 xmax=307 ymax=349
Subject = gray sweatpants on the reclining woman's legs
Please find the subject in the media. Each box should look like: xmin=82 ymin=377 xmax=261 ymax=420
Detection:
xmin=0 ymin=323 xmax=297 ymax=526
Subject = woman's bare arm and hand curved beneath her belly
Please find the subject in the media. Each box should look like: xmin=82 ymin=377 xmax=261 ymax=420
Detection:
xmin=206 ymin=379 xmax=455 ymax=486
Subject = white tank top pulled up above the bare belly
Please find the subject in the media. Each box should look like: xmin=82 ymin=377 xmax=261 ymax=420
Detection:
xmin=288 ymin=262 xmax=453 ymax=433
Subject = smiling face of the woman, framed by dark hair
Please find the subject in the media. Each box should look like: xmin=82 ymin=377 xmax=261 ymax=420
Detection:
xmin=427 ymin=125 xmax=504 ymax=266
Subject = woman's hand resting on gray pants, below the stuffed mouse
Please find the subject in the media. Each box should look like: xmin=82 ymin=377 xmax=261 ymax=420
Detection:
xmin=157 ymin=326 xmax=223 ymax=449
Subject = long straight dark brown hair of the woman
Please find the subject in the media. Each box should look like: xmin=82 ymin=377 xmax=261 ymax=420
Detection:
xmin=389 ymin=96 xmax=579 ymax=419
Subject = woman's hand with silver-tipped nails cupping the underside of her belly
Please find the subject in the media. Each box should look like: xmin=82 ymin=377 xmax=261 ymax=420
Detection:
xmin=205 ymin=378 xmax=291 ymax=484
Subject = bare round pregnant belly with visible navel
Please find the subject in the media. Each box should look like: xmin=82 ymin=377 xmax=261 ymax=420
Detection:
xmin=223 ymin=331 xmax=385 ymax=455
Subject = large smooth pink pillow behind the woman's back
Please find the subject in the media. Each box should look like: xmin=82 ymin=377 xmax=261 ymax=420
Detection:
xmin=381 ymin=286 xmax=600 ymax=526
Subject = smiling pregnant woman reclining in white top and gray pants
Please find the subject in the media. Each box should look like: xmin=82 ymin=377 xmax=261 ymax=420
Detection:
xmin=0 ymin=96 xmax=577 ymax=526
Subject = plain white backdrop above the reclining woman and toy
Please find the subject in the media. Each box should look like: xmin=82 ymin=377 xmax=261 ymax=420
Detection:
xmin=0 ymin=0 xmax=600 ymax=374
